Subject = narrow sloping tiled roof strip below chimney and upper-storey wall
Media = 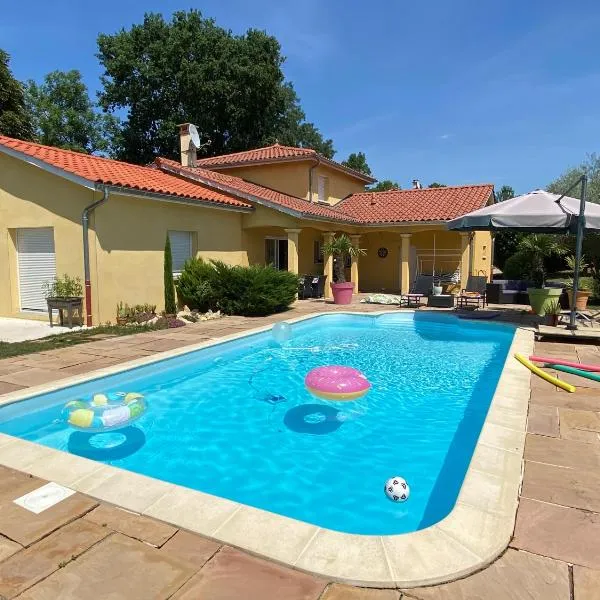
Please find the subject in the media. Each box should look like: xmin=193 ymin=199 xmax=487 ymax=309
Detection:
xmin=155 ymin=158 xmax=355 ymax=223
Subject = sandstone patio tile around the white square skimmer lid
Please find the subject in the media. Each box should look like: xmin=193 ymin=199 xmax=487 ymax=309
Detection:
xmin=0 ymin=485 xmax=98 ymax=546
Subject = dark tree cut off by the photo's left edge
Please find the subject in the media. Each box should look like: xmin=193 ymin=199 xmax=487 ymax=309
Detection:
xmin=0 ymin=49 xmax=33 ymax=140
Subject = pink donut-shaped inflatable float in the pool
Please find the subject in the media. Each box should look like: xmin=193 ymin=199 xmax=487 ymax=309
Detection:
xmin=304 ymin=365 xmax=371 ymax=400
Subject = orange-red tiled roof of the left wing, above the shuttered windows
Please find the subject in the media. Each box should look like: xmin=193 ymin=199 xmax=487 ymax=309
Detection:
xmin=0 ymin=135 xmax=252 ymax=208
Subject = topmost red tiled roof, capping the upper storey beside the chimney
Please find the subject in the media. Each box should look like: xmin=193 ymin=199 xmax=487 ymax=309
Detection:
xmin=196 ymin=144 xmax=376 ymax=183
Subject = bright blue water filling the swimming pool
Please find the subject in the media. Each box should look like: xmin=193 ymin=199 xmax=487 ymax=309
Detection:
xmin=0 ymin=313 xmax=514 ymax=535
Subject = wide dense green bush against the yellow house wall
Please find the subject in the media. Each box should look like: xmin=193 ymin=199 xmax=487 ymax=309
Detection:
xmin=177 ymin=259 xmax=298 ymax=316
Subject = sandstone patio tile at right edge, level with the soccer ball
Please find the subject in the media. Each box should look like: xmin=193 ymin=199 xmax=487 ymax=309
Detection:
xmin=521 ymin=461 xmax=600 ymax=513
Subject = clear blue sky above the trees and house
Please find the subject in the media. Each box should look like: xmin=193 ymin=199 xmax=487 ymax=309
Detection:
xmin=0 ymin=0 xmax=600 ymax=193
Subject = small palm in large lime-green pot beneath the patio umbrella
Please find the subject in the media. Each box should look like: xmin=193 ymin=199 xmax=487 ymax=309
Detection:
xmin=519 ymin=233 xmax=565 ymax=317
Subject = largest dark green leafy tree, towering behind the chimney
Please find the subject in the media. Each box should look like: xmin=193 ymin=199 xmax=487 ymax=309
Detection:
xmin=98 ymin=10 xmax=333 ymax=163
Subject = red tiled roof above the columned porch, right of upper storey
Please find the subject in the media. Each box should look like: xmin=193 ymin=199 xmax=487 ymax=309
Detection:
xmin=335 ymin=184 xmax=494 ymax=223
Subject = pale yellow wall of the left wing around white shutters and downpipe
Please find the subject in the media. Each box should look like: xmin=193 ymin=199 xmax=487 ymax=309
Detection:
xmin=0 ymin=154 xmax=248 ymax=324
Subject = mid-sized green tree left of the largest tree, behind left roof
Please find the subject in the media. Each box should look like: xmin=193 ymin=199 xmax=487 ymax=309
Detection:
xmin=25 ymin=70 xmax=115 ymax=154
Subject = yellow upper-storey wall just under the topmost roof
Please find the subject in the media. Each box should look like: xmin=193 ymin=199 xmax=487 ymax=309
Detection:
xmin=214 ymin=161 xmax=365 ymax=204
